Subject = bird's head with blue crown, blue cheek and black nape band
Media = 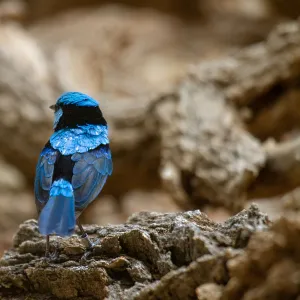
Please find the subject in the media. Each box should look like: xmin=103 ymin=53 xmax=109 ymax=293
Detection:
xmin=50 ymin=92 xmax=107 ymax=131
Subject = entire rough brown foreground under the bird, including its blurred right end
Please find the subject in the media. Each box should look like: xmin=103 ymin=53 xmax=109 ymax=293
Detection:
xmin=0 ymin=206 xmax=300 ymax=300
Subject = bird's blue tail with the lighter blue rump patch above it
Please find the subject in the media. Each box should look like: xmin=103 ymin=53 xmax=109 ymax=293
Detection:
xmin=39 ymin=179 xmax=76 ymax=236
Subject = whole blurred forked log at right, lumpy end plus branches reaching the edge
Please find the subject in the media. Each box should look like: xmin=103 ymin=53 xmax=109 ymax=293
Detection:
xmin=153 ymin=21 xmax=300 ymax=210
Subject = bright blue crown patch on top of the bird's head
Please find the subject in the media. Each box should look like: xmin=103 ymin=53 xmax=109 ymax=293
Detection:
xmin=56 ymin=92 xmax=99 ymax=107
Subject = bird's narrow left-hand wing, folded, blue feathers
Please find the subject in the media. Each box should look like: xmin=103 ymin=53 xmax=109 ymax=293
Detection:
xmin=34 ymin=145 xmax=59 ymax=210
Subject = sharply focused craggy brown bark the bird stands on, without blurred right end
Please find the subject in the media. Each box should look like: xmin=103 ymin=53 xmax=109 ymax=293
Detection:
xmin=0 ymin=206 xmax=269 ymax=299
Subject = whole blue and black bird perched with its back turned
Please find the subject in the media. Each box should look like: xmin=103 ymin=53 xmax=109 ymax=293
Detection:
xmin=34 ymin=92 xmax=113 ymax=256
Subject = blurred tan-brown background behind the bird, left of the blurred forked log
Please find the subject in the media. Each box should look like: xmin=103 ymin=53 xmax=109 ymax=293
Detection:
xmin=0 ymin=0 xmax=300 ymax=253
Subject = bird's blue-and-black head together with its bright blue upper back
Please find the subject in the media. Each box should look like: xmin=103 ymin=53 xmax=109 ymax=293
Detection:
xmin=50 ymin=92 xmax=109 ymax=155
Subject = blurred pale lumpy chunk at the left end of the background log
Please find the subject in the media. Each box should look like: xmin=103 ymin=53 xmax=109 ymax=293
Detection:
xmin=154 ymin=73 xmax=265 ymax=210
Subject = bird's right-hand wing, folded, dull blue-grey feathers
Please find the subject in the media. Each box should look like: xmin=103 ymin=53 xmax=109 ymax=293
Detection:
xmin=71 ymin=145 xmax=113 ymax=212
